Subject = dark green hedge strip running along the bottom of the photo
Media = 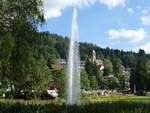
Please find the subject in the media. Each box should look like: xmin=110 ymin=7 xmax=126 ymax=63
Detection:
xmin=0 ymin=102 xmax=150 ymax=113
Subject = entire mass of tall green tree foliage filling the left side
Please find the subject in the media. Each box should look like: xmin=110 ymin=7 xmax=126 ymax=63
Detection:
xmin=0 ymin=0 xmax=50 ymax=90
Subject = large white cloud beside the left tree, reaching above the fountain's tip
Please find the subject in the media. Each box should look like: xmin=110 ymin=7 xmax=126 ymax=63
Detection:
xmin=44 ymin=0 xmax=96 ymax=19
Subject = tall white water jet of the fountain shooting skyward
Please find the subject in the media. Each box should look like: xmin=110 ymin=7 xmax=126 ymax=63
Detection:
xmin=67 ymin=8 xmax=80 ymax=105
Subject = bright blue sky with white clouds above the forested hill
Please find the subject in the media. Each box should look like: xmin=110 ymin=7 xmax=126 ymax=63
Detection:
xmin=39 ymin=0 xmax=150 ymax=53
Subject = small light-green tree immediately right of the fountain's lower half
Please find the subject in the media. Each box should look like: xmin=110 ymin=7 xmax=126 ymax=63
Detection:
xmin=81 ymin=69 xmax=90 ymax=90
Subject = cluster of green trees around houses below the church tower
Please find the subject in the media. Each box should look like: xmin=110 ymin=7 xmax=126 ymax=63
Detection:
xmin=85 ymin=58 xmax=129 ymax=90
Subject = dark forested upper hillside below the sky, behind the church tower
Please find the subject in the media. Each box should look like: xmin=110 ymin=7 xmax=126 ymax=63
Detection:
xmin=40 ymin=32 xmax=150 ymax=67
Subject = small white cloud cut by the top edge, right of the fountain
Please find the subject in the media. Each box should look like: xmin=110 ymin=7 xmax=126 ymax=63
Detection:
xmin=100 ymin=0 xmax=126 ymax=8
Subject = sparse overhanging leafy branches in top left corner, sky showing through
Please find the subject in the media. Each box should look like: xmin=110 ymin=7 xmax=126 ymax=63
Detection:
xmin=0 ymin=0 xmax=44 ymax=30
